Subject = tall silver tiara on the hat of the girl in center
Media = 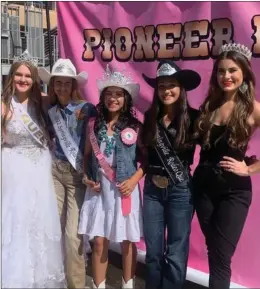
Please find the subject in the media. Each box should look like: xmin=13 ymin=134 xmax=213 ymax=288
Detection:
xmin=99 ymin=64 xmax=133 ymax=85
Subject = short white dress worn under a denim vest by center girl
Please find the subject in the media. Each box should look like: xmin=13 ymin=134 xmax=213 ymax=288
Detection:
xmin=78 ymin=136 xmax=143 ymax=243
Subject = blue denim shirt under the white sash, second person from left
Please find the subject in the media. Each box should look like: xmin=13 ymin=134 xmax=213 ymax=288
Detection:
xmin=48 ymin=101 xmax=96 ymax=161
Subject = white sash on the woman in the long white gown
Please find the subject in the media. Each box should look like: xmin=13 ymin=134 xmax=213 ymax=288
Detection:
xmin=12 ymin=97 xmax=47 ymax=148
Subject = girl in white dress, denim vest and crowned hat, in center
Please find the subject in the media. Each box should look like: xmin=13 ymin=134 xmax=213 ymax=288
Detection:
xmin=79 ymin=66 xmax=143 ymax=288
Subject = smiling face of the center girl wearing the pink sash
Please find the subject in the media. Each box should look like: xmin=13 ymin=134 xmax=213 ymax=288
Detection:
xmin=104 ymin=86 xmax=125 ymax=112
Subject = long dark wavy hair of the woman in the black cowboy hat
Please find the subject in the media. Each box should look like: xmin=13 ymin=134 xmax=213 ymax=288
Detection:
xmin=141 ymin=83 xmax=192 ymax=148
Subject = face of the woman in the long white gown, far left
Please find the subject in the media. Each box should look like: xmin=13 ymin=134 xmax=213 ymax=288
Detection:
xmin=14 ymin=64 xmax=33 ymax=94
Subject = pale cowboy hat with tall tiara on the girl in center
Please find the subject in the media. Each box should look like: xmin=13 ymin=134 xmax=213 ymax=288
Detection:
xmin=97 ymin=65 xmax=140 ymax=101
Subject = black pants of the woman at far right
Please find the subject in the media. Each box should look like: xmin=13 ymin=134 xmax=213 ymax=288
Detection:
xmin=194 ymin=173 xmax=252 ymax=289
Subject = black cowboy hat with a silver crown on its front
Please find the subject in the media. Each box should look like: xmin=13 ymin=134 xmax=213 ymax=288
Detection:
xmin=142 ymin=60 xmax=201 ymax=90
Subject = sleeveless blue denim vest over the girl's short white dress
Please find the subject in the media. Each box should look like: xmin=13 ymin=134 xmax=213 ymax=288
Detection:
xmin=86 ymin=129 xmax=137 ymax=183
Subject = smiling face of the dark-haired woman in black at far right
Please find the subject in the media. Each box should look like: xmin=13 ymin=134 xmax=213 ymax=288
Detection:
xmin=217 ymin=59 xmax=243 ymax=93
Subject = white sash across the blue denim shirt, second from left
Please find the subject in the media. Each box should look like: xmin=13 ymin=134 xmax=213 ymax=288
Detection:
xmin=48 ymin=105 xmax=83 ymax=174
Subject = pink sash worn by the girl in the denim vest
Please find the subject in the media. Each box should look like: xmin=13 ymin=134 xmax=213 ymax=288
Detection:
xmin=88 ymin=118 xmax=131 ymax=216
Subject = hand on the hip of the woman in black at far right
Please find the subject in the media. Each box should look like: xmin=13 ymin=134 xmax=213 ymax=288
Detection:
xmin=219 ymin=156 xmax=249 ymax=177
